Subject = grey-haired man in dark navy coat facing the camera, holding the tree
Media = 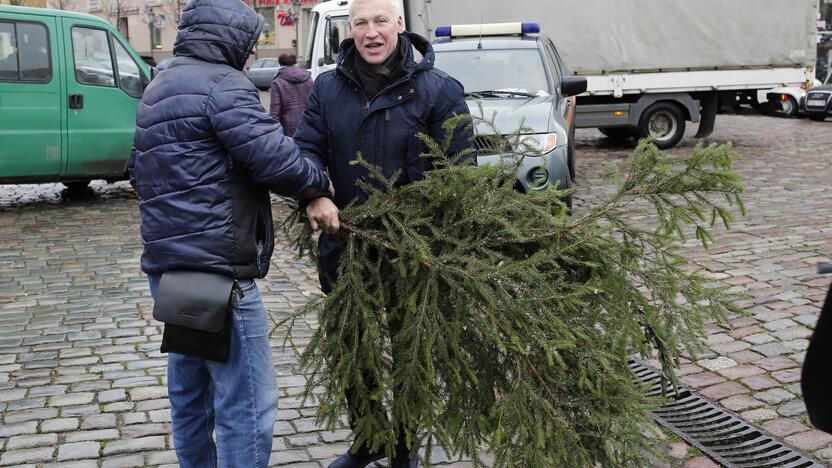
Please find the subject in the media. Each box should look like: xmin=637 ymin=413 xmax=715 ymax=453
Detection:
xmin=294 ymin=0 xmax=472 ymax=468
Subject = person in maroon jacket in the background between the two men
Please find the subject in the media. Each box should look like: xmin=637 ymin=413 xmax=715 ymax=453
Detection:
xmin=269 ymin=54 xmax=312 ymax=136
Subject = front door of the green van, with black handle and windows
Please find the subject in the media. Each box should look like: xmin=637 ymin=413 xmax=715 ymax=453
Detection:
xmin=62 ymin=18 xmax=148 ymax=179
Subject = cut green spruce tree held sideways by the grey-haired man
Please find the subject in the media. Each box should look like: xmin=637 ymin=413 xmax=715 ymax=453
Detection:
xmin=284 ymin=114 xmax=745 ymax=467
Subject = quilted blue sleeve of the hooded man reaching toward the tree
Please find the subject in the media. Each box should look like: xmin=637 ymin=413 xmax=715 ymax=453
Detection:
xmin=206 ymin=73 xmax=329 ymax=200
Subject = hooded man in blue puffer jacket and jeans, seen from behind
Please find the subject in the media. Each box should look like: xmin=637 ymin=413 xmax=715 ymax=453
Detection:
xmin=129 ymin=0 xmax=331 ymax=468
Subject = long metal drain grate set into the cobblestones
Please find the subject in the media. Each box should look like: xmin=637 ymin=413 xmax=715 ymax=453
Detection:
xmin=630 ymin=361 xmax=826 ymax=468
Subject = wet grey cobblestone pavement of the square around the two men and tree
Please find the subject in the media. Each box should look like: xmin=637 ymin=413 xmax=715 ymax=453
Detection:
xmin=0 ymin=111 xmax=832 ymax=467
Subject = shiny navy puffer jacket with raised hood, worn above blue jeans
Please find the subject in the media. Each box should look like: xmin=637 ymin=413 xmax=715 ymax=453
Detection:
xmin=128 ymin=0 xmax=329 ymax=278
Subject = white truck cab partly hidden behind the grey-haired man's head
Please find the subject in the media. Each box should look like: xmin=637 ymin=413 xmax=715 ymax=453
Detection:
xmin=300 ymin=0 xmax=405 ymax=79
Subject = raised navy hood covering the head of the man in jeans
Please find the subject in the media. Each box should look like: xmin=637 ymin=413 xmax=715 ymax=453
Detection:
xmin=173 ymin=0 xmax=263 ymax=70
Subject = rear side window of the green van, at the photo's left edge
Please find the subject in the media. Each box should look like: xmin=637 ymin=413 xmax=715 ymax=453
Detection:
xmin=0 ymin=21 xmax=52 ymax=83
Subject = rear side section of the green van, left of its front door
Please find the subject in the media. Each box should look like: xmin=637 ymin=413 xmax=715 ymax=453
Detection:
xmin=0 ymin=12 xmax=63 ymax=181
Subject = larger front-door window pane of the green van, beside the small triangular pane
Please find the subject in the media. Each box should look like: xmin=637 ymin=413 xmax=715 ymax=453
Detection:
xmin=72 ymin=26 xmax=116 ymax=88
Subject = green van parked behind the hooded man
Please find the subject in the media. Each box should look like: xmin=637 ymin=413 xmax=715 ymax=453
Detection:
xmin=0 ymin=5 xmax=151 ymax=187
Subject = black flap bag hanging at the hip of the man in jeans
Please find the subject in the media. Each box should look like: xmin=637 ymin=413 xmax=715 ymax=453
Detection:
xmin=153 ymin=270 xmax=236 ymax=362
